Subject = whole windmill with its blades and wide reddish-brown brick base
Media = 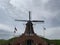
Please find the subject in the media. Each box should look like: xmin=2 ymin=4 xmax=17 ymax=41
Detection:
xmin=12 ymin=11 xmax=48 ymax=45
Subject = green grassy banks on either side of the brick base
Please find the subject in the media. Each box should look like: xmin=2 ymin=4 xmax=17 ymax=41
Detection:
xmin=0 ymin=37 xmax=60 ymax=45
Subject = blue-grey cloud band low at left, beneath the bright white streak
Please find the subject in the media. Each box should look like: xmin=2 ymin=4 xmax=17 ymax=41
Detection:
xmin=0 ymin=29 xmax=13 ymax=39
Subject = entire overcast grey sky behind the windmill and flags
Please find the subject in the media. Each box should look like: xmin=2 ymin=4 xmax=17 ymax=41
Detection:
xmin=0 ymin=0 xmax=60 ymax=39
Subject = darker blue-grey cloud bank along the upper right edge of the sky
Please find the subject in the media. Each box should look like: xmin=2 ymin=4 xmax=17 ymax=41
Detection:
xmin=45 ymin=0 xmax=60 ymax=27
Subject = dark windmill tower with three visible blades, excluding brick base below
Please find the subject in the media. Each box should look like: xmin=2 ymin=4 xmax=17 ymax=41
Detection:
xmin=15 ymin=11 xmax=44 ymax=35
